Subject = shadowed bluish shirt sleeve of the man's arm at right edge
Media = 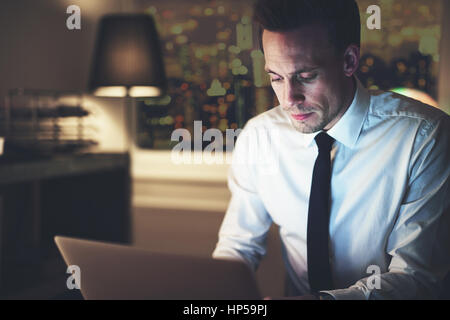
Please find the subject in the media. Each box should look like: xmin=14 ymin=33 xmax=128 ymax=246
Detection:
xmin=324 ymin=115 xmax=450 ymax=299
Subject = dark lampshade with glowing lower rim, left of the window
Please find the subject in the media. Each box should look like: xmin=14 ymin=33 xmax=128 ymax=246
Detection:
xmin=89 ymin=14 xmax=166 ymax=97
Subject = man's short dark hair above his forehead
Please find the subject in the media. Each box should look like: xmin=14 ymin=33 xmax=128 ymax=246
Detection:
xmin=253 ymin=0 xmax=361 ymax=53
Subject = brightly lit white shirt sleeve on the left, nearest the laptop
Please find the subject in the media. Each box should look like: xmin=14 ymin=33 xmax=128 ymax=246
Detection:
xmin=213 ymin=122 xmax=272 ymax=270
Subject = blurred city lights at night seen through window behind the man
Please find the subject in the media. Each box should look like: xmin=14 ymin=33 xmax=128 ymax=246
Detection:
xmin=137 ymin=0 xmax=441 ymax=149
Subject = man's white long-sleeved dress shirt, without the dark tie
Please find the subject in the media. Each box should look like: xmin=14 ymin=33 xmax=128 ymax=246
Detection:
xmin=213 ymin=81 xmax=450 ymax=299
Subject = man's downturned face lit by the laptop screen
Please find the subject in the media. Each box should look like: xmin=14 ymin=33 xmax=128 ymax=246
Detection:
xmin=262 ymin=25 xmax=348 ymax=133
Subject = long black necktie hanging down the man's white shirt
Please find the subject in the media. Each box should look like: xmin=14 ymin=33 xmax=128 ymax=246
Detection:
xmin=307 ymin=132 xmax=334 ymax=293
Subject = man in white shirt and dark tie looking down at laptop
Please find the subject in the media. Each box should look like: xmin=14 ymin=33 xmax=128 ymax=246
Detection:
xmin=213 ymin=0 xmax=450 ymax=299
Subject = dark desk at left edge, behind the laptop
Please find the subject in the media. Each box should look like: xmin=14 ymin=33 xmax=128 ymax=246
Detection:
xmin=0 ymin=154 xmax=131 ymax=299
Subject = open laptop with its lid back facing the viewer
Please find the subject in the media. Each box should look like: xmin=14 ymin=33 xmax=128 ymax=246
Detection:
xmin=55 ymin=236 xmax=262 ymax=300
